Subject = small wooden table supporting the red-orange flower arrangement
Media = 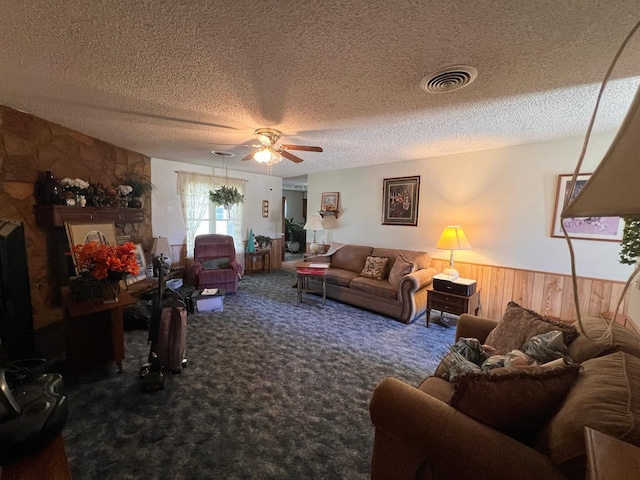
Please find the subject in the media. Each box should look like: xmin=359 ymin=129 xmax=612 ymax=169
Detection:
xmin=62 ymin=287 xmax=136 ymax=372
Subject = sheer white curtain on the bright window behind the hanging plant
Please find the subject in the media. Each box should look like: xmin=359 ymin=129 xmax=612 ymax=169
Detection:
xmin=177 ymin=172 xmax=244 ymax=257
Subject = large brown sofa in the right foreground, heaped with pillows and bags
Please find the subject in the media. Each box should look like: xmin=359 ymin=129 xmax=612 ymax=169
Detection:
xmin=370 ymin=315 xmax=640 ymax=480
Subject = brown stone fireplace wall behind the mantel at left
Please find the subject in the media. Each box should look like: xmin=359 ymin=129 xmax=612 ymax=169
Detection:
xmin=0 ymin=105 xmax=152 ymax=329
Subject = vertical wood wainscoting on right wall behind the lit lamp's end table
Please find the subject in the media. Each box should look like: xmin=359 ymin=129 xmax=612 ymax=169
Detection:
xmin=431 ymin=258 xmax=636 ymax=330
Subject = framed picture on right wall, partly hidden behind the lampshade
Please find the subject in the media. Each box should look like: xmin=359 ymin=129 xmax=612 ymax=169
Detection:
xmin=551 ymin=173 xmax=624 ymax=242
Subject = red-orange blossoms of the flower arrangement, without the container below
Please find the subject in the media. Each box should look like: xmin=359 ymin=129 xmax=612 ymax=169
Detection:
xmin=71 ymin=242 xmax=140 ymax=280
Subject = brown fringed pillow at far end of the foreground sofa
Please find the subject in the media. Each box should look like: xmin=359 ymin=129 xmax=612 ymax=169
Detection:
xmin=484 ymin=302 xmax=578 ymax=354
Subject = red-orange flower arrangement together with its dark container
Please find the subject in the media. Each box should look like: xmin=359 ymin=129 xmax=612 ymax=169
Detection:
xmin=69 ymin=242 xmax=140 ymax=303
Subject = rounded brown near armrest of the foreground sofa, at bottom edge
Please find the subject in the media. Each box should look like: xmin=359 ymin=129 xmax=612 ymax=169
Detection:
xmin=369 ymin=377 xmax=565 ymax=480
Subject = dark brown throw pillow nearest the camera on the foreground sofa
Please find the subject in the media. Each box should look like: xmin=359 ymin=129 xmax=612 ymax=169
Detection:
xmin=449 ymin=363 xmax=580 ymax=442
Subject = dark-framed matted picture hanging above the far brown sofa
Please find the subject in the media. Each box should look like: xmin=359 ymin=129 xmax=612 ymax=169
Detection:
xmin=382 ymin=175 xmax=420 ymax=227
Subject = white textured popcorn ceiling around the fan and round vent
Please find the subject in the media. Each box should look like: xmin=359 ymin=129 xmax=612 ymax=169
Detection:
xmin=0 ymin=0 xmax=640 ymax=187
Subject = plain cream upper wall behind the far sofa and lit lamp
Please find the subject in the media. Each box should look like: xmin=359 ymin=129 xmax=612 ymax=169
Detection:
xmin=307 ymin=131 xmax=640 ymax=326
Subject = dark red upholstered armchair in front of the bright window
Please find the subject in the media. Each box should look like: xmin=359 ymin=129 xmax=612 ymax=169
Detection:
xmin=191 ymin=234 xmax=242 ymax=293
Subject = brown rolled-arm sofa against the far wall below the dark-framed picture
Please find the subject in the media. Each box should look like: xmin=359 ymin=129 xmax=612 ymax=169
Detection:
xmin=305 ymin=245 xmax=438 ymax=323
